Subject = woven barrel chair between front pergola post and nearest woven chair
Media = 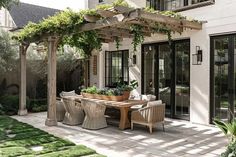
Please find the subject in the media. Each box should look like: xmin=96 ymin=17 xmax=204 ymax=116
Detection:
xmin=62 ymin=97 xmax=84 ymax=125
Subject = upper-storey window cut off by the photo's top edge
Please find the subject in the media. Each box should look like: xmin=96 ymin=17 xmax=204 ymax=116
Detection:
xmin=147 ymin=0 xmax=214 ymax=11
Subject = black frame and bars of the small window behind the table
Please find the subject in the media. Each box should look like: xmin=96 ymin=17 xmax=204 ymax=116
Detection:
xmin=105 ymin=49 xmax=129 ymax=88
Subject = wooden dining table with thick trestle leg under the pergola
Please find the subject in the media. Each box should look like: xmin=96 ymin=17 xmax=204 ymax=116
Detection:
xmin=75 ymin=95 xmax=148 ymax=130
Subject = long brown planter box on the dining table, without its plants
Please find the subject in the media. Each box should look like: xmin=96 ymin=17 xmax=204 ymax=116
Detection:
xmin=81 ymin=93 xmax=125 ymax=101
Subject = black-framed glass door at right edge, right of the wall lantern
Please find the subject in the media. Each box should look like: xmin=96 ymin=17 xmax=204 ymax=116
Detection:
xmin=210 ymin=35 xmax=236 ymax=122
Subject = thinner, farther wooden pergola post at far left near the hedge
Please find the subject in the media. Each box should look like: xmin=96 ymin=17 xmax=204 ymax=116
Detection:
xmin=18 ymin=44 xmax=29 ymax=116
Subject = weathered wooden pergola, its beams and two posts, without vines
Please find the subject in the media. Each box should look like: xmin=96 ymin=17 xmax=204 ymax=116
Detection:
xmin=18 ymin=6 xmax=202 ymax=126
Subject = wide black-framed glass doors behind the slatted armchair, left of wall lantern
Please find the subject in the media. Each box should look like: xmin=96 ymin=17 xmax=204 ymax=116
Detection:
xmin=142 ymin=40 xmax=190 ymax=119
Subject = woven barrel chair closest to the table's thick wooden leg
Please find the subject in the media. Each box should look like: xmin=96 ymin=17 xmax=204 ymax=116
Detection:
xmin=81 ymin=99 xmax=107 ymax=130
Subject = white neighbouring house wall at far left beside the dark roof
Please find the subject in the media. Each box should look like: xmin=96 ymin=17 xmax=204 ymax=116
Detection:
xmin=0 ymin=8 xmax=15 ymax=30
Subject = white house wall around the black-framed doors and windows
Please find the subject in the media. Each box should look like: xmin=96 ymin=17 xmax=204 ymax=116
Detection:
xmin=91 ymin=0 xmax=236 ymax=124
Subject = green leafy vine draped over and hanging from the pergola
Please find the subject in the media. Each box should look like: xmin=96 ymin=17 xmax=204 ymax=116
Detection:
xmin=14 ymin=0 xmax=199 ymax=56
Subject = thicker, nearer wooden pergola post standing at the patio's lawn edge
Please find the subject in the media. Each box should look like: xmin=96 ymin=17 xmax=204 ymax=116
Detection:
xmin=45 ymin=37 xmax=58 ymax=126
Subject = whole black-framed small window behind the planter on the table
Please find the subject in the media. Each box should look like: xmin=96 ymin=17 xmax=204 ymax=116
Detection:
xmin=105 ymin=50 xmax=129 ymax=87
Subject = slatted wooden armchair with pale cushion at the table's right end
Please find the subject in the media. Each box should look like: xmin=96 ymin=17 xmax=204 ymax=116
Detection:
xmin=131 ymin=100 xmax=165 ymax=133
